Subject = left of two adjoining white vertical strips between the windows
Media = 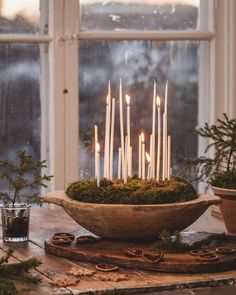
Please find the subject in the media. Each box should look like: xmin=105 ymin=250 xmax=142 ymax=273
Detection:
xmin=49 ymin=0 xmax=65 ymax=189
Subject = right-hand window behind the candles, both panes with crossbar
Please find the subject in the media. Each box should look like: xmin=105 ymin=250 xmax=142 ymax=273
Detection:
xmin=79 ymin=0 xmax=212 ymax=185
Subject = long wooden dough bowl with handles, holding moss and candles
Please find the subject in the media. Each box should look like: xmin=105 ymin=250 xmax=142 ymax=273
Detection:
xmin=44 ymin=191 xmax=221 ymax=240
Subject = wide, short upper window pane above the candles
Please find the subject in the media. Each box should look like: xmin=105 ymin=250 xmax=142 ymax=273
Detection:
xmin=80 ymin=0 xmax=200 ymax=31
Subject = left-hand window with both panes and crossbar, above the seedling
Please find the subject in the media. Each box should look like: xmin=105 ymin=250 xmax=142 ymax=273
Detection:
xmin=0 ymin=0 xmax=48 ymax=175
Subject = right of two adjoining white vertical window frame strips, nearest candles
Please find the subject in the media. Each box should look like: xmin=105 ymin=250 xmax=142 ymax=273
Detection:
xmin=64 ymin=0 xmax=79 ymax=184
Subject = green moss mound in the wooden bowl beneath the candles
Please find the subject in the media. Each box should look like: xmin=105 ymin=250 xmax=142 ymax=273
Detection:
xmin=66 ymin=177 xmax=198 ymax=205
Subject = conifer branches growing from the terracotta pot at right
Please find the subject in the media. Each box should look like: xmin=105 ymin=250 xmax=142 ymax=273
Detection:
xmin=181 ymin=113 xmax=236 ymax=187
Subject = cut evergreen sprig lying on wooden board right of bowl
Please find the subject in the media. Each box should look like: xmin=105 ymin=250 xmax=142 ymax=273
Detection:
xmin=153 ymin=230 xmax=227 ymax=251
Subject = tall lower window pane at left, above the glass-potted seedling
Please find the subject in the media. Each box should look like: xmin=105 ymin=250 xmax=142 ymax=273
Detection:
xmin=0 ymin=44 xmax=46 ymax=163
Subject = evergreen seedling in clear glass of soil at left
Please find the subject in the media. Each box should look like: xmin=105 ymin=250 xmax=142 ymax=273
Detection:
xmin=0 ymin=151 xmax=51 ymax=242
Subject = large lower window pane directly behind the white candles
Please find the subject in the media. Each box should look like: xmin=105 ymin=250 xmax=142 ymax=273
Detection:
xmin=79 ymin=41 xmax=206 ymax=182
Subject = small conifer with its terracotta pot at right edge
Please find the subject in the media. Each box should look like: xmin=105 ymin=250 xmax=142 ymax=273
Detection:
xmin=182 ymin=113 xmax=236 ymax=234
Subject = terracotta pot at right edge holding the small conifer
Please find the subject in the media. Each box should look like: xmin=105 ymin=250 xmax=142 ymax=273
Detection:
xmin=211 ymin=186 xmax=236 ymax=234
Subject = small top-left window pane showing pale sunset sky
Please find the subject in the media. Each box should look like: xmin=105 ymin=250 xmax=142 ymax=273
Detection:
xmin=0 ymin=0 xmax=40 ymax=34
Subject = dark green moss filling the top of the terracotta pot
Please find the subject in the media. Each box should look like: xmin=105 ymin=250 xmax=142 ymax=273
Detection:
xmin=210 ymin=170 xmax=236 ymax=189
